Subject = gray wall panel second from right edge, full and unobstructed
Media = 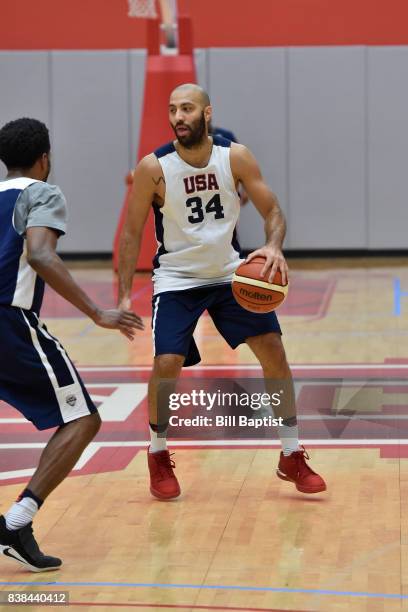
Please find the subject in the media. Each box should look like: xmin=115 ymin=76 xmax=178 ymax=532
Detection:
xmin=289 ymin=47 xmax=367 ymax=249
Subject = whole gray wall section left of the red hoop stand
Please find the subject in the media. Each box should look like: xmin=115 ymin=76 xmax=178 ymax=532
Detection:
xmin=0 ymin=50 xmax=145 ymax=253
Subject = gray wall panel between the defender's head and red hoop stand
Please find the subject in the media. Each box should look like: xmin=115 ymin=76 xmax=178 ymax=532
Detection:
xmin=52 ymin=51 xmax=130 ymax=252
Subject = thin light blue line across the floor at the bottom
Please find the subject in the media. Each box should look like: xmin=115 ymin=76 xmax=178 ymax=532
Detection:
xmin=0 ymin=581 xmax=408 ymax=599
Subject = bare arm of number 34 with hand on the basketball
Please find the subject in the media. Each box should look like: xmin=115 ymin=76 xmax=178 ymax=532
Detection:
xmin=231 ymin=143 xmax=288 ymax=283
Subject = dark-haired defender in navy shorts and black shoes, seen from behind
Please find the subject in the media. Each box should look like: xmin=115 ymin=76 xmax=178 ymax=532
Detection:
xmin=0 ymin=118 xmax=143 ymax=572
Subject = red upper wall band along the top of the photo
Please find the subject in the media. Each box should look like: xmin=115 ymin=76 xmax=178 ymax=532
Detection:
xmin=0 ymin=0 xmax=408 ymax=49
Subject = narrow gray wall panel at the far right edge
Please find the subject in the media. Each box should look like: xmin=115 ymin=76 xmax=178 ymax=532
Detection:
xmin=368 ymin=47 xmax=408 ymax=249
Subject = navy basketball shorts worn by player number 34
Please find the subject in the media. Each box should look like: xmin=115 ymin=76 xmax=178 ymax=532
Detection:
xmin=152 ymin=284 xmax=282 ymax=366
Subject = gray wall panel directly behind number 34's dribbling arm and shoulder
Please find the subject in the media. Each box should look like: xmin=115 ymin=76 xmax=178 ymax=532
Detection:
xmin=208 ymin=48 xmax=290 ymax=249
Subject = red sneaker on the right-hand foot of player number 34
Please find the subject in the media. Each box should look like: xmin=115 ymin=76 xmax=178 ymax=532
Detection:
xmin=276 ymin=446 xmax=326 ymax=493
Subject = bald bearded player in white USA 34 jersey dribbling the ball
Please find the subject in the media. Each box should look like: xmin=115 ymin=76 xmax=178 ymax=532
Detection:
xmin=119 ymin=84 xmax=326 ymax=499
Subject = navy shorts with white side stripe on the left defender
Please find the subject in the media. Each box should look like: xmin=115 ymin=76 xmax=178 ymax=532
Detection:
xmin=0 ymin=305 xmax=97 ymax=429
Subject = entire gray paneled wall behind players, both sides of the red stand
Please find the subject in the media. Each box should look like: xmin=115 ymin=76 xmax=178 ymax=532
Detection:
xmin=0 ymin=47 xmax=408 ymax=252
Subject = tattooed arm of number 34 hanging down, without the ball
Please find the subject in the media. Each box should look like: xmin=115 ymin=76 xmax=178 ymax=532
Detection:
xmin=118 ymin=154 xmax=161 ymax=309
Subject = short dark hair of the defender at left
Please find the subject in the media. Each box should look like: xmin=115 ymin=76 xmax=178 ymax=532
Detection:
xmin=0 ymin=117 xmax=51 ymax=170
